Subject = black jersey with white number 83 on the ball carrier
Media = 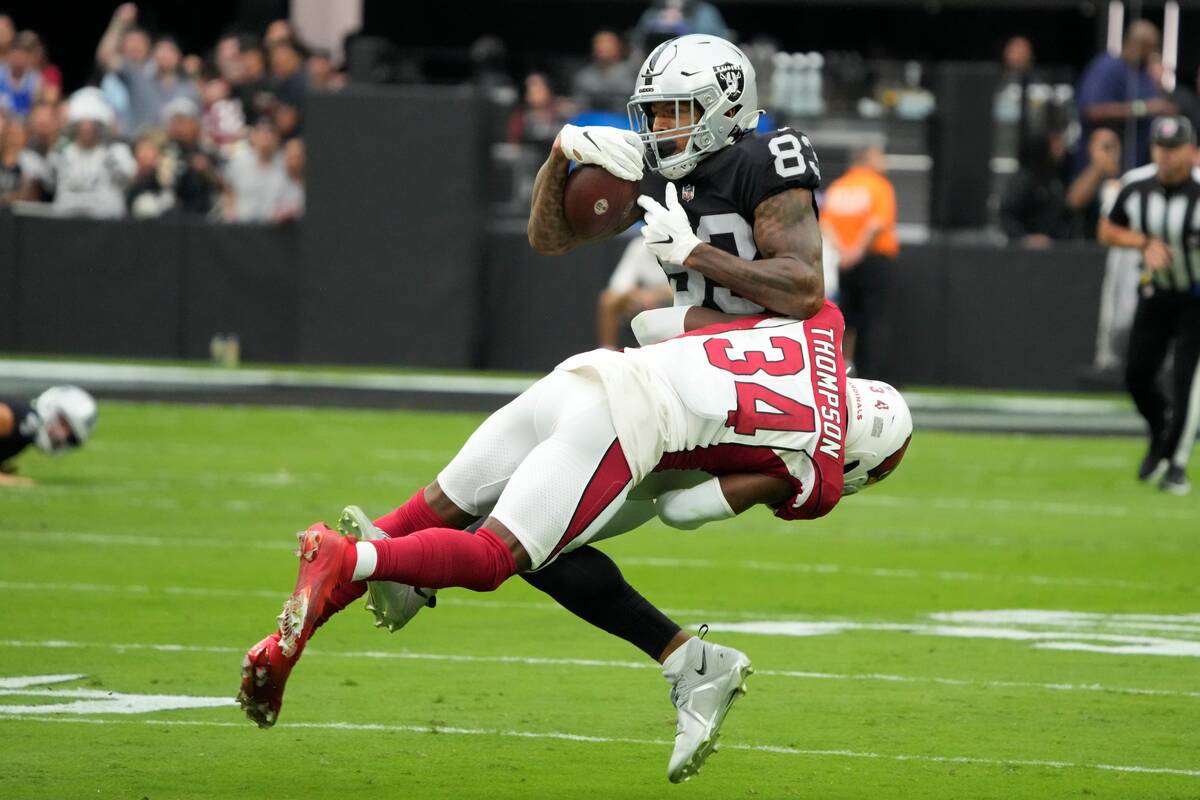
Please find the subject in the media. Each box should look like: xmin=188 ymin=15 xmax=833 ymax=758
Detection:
xmin=641 ymin=128 xmax=821 ymax=314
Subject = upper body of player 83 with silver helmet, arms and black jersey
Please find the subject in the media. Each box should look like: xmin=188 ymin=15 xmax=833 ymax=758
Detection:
xmin=529 ymin=35 xmax=824 ymax=331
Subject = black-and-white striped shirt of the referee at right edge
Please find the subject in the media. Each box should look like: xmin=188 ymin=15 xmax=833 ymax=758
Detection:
xmin=1109 ymin=164 xmax=1200 ymax=296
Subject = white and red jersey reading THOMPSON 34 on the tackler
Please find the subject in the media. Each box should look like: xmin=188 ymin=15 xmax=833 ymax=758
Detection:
xmin=558 ymin=302 xmax=846 ymax=519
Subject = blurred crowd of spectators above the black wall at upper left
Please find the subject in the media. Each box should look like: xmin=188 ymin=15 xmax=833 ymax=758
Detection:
xmin=0 ymin=2 xmax=346 ymax=223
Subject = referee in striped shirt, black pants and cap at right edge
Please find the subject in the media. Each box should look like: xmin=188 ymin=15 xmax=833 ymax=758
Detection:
xmin=1099 ymin=116 xmax=1200 ymax=494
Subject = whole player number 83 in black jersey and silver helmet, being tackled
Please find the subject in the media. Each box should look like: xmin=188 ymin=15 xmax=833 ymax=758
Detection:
xmin=523 ymin=35 xmax=824 ymax=781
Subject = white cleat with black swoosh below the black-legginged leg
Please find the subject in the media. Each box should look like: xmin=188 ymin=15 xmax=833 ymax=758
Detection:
xmin=662 ymin=626 xmax=754 ymax=783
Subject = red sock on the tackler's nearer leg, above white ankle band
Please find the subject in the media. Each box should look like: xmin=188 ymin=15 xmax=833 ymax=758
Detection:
xmin=371 ymin=528 xmax=517 ymax=591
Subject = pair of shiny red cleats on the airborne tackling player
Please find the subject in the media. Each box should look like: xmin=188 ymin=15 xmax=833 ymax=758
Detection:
xmin=238 ymin=523 xmax=358 ymax=728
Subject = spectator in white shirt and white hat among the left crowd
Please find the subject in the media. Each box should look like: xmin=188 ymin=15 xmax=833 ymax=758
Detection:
xmin=46 ymin=88 xmax=136 ymax=218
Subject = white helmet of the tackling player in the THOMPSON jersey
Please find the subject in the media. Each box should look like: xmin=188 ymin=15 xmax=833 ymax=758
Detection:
xmin=841 ymin=378 xmax=912 ymax=497
